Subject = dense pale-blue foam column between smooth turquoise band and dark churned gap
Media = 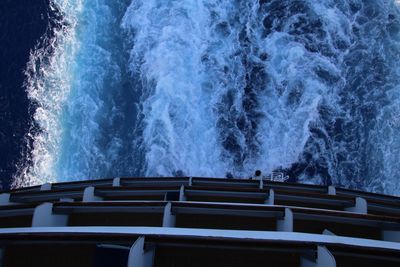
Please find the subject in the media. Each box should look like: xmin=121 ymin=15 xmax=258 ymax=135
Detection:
xmin=122 ymin=1 xmax=232 ymax=176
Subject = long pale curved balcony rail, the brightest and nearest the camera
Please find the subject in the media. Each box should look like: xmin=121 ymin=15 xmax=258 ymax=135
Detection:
xmin=0 ymin=226 xmax=400 ymax=253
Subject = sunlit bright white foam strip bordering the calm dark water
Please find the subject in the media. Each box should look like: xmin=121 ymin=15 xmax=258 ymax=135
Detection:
xmin=13 ymin=0 xmax=82 ymax=187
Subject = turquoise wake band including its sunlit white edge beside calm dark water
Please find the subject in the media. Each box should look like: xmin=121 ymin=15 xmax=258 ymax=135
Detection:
xmin=14 ymin=0 xmax=139 ymax=186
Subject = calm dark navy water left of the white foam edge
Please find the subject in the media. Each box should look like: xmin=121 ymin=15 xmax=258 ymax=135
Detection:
xmin=0 ymin=0 xmax=61 ymax=191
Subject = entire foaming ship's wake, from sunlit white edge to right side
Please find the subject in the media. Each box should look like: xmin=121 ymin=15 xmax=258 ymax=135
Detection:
xmin=10 ymin=0 xmax=400 ymax=195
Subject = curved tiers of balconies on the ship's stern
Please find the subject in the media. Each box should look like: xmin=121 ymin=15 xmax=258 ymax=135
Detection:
xmin=0 ymin=177 xmax=400 ymax=267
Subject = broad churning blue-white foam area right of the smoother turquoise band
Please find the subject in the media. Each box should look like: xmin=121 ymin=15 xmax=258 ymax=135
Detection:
xmin=123 ymin=0 xmax=400 ymax=194
